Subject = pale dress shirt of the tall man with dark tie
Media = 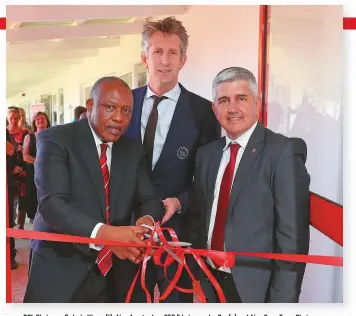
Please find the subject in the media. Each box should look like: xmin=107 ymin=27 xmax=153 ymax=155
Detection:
xmin=141 ymin=83 xmax=181 ymax=170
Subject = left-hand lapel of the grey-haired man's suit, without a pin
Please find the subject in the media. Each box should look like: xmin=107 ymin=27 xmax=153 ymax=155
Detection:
xmin=206 ymin=137 xmax=226 ymax=229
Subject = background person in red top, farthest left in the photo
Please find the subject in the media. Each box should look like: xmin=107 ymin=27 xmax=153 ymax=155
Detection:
xmin=7 ymin=107 xmax=29 ymax=229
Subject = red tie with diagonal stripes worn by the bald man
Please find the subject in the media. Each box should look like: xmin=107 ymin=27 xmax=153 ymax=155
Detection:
xmin=98 ymin=143 xmax=112 ymax=275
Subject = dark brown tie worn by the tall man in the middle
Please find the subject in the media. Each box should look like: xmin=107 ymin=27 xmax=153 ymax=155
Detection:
xmin=143 ymin=95 xmax=167 ymax=171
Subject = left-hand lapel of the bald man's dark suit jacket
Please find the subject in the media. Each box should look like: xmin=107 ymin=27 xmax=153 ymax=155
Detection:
xmin=78 ymin=120 xmax=105 ymax=218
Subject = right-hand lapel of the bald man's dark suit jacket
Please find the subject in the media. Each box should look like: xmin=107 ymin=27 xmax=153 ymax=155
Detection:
xmin=110 ymin=137 xmax=130 ymax=220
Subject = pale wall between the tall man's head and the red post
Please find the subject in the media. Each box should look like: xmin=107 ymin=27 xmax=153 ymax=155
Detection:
xmin=179 ymin=6 xmax=259 ymax=100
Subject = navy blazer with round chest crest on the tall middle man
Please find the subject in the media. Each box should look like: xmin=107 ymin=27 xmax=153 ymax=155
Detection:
xmin=126 ymin=85 xmax=221 ymax=234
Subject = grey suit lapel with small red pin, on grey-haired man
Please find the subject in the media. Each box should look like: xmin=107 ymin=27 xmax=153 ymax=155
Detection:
xmin=229 ymin=123 xmax=265 ymax=214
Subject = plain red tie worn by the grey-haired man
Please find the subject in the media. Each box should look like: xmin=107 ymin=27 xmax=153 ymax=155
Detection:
xmin=211 ymin=143 xmax=240 ymax=269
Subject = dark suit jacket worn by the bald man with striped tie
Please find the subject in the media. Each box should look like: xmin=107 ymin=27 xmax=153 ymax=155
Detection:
xmin=25 ymin=120 xmax=164 ymax=302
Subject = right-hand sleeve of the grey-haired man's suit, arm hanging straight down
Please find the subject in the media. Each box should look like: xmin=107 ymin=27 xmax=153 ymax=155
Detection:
xmin=268 ymin=139 xmax=310 ymax=303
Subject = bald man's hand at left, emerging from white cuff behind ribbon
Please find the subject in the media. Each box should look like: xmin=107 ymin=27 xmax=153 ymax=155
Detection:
xmin=96 ymin=225 xmax=145 ymax=264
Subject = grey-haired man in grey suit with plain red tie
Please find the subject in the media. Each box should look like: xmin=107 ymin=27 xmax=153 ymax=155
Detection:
xmin=191 ymin=67 xmax=310 ymax=303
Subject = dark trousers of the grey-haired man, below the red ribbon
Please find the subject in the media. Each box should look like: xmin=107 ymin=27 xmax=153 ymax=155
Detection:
xmin=204 ymin=266 xmax=242 ymax=303
